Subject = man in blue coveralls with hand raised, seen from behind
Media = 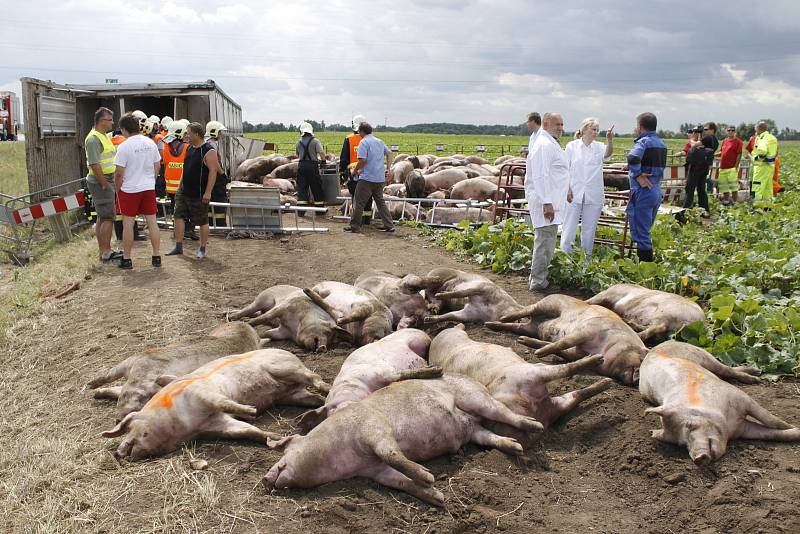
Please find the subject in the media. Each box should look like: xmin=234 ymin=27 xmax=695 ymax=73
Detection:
xmin=627 ymin=113 xmax=667 ymax=261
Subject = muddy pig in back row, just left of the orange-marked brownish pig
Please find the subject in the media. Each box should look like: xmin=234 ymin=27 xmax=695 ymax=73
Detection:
xmin=422 ymin=267 xmax=525 ymax=324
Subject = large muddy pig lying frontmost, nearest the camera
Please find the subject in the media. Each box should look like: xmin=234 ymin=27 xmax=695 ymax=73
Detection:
xmin=264 ymin=375 xmax=542 ymax=506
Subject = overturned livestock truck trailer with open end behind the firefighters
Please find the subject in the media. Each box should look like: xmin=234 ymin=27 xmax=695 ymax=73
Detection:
xmin=20 ymin=78 xmax=263 ymax=197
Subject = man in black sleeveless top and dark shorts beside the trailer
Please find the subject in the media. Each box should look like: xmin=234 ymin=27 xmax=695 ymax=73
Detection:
xmin=165 ymin=122 xmax=221 ymax=259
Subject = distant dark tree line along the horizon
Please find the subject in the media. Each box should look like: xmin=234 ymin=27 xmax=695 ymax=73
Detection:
xmin=243 ymin=119 xmax=800 ymax=140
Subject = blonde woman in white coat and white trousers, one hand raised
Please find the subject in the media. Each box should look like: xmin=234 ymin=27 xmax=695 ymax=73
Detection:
xmin=561 ymin=117 xmax=614 ymax=261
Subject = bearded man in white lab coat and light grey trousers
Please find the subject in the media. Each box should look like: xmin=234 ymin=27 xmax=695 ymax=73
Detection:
xmin=525 ymin=113 xmax=569 ymax=293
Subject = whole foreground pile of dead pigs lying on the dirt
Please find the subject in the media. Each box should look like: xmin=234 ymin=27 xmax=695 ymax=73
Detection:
xmin=89 ymin=276 xmax=800 ymax=505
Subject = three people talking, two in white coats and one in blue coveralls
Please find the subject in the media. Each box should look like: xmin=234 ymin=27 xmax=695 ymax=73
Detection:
xmin=525 ymin=113 xmax=667 ymax=292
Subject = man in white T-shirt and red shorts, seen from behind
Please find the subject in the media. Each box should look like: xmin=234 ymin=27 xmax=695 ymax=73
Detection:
xmin=114 ymin=113 xmax=161 ymax=269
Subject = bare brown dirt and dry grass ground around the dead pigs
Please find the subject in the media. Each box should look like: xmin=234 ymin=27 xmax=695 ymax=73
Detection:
xmin=0 ymin=223 xmax=800 ymax=533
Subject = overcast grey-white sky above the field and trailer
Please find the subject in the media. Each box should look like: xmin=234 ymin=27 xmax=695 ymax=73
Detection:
xmin=6 ymin=0 xmax=800 ymax=131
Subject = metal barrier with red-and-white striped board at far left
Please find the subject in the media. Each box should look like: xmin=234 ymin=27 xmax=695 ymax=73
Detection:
xmin=0 ymin=178 xmax=84 ymax=265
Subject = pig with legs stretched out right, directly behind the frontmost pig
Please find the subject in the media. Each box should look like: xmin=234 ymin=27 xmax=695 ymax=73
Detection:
xmin=432 ymin=325 xmax=614 ymax=447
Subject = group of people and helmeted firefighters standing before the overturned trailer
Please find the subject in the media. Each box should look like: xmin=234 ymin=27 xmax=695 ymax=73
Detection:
xmin=84 ymin=107 xmax=225 ymax=269
